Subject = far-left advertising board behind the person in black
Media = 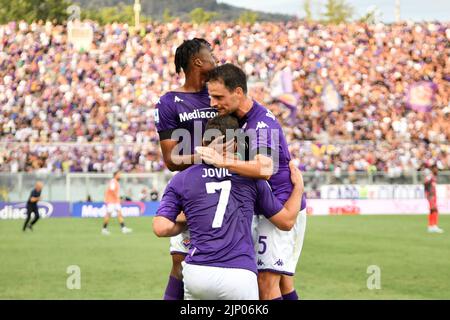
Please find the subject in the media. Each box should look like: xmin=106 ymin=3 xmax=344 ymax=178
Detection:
xmin=0 ymin=201 xmax=70 ymax=220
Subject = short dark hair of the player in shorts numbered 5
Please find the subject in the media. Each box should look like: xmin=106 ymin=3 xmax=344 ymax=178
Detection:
xmin=209 ymin=63 xmax=247 ymax=94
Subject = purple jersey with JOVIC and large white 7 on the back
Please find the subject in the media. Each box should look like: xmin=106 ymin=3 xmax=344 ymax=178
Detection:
xmin=157 ymin=164 xmax=283 ymax=273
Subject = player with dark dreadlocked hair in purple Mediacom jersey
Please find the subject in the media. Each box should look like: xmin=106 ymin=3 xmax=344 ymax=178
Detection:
xmin=155 ymin=38 xmax=221 ymax=300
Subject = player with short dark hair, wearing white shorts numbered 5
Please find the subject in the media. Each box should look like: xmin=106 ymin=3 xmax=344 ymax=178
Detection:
xmin=198 ymin=64 xmax=306 ymax=300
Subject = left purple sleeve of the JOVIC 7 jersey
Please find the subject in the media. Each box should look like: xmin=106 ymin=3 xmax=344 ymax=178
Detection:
xmin=156 ymin=174 xmax=183 ymax=222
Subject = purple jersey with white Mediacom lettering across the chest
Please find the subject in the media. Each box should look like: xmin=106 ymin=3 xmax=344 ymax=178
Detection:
xmin=155 ymin=87 xmax=217 ymax=155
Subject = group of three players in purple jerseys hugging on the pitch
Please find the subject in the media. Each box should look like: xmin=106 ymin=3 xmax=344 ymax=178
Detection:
xmin=154 ymin=39 xmax=306 ymax=300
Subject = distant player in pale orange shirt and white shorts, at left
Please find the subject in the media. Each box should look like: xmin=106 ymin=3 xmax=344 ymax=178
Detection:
xmin=102 ymin=171 xmax=133 ymax=235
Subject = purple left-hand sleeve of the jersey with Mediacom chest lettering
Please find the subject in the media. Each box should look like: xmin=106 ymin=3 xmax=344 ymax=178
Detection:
xmin=155 ymin=97 xmax=178 ymax=140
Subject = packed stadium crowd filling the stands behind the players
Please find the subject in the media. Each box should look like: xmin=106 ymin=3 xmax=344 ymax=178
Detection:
xmin=0 ymin=20 xmax=450 ymax=175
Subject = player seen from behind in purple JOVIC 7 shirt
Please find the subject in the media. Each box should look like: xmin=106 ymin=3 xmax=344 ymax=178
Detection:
xmin=153 ymin=116 xmax=303 ymax=300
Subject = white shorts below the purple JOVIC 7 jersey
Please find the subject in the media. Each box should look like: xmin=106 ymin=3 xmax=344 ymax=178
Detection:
xmin=181 ymin=261 xmax=259 ymax=300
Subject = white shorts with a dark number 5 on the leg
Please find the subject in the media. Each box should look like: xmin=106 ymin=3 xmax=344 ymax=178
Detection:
xmin=255 ymin=209 xmax=306 ymax=276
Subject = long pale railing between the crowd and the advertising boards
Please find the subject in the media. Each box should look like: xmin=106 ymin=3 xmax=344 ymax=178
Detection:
xmin=0 ymin=171 xmax=450 ymax=202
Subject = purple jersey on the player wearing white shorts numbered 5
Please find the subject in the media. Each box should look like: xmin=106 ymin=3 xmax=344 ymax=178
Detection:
xmin=239 ymin=101 xmax=306 ymax=210
